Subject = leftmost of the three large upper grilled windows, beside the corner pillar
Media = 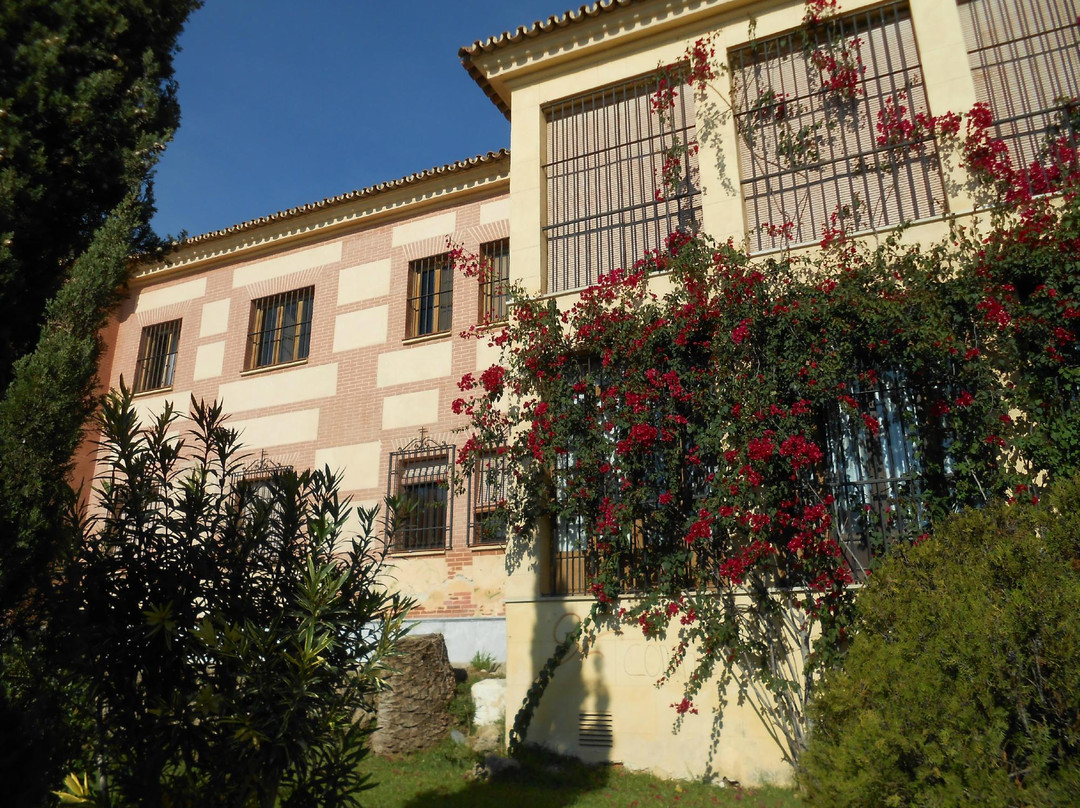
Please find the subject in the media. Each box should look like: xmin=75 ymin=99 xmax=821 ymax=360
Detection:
xmin=543 ymin=77 xmax=701 ymax=293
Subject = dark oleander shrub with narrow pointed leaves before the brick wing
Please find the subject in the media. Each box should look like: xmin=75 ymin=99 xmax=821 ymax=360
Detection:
xmin=52 ymin=390 xmax=409 ymax=807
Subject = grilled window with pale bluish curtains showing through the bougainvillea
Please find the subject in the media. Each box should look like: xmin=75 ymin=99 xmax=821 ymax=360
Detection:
xmin=824 ymin=371 xmax=924 ymax=578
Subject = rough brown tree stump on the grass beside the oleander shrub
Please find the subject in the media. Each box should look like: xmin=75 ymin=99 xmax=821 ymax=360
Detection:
xmin=372 ymin=634 xmax=456 ymax=755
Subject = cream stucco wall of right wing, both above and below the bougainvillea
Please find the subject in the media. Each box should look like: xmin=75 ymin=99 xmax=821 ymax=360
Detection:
xmin=494 ymin=0 xmax=997 ymax=783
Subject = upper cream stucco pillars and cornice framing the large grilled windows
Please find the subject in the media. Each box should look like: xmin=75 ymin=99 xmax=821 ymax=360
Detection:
xmin=499 ymin=0 xmax=989 ymax=300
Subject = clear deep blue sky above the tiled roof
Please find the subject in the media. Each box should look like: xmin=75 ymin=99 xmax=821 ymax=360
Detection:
xmin=153 ymin=0 xmax=580 ymax=235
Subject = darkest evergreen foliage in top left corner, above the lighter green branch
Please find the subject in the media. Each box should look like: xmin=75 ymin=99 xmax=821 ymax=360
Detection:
xmin=0 ymin=0 xmax=201 ymax=391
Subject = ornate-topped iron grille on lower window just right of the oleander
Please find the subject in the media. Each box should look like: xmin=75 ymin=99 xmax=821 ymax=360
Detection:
xmin=387 ymin=432 xmax=455 ymax=553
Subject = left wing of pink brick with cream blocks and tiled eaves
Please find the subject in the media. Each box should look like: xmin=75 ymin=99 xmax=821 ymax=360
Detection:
xmin=87 ymin=151 xmax=510 ymax=661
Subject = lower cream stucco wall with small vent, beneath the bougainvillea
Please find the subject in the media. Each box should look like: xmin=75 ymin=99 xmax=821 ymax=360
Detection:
xmin=507 ymin=598 xmax=791 ymax=785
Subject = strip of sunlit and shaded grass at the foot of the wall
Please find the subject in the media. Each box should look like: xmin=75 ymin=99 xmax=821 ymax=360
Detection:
xmin=361 ymin=741 xmax=801 ymax=808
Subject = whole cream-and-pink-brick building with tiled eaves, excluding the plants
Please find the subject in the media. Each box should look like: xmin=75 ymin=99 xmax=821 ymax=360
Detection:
xmin=88 ymin=0 xmax=1080 ymax=782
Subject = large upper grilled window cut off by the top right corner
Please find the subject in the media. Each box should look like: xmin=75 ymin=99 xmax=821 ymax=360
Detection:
xmin=959 ymin=0 xmax=1080 ymax=192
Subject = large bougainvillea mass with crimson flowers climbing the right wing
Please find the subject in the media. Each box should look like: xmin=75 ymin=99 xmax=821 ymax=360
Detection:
xmin=455 ymin=187 xmax=1080 ymax=763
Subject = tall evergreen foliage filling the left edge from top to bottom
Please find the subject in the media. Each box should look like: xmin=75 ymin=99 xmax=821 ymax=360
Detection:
xmin=0 ymin=0 xmax=201 ymax=805
